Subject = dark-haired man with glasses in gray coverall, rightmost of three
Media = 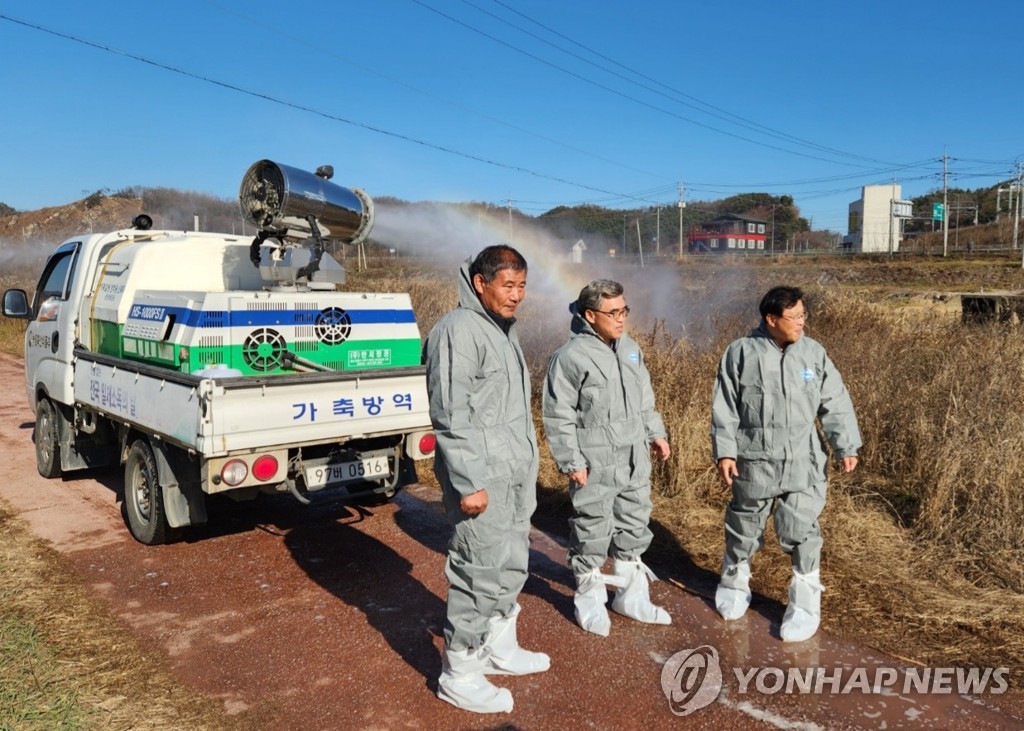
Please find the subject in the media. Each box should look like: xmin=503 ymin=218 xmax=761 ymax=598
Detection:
xmin=711 ymin=287 xmax=861 ymax=642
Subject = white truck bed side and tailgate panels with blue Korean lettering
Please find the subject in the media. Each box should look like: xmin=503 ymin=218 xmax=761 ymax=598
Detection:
xmin=73 ymin=348 xmax=430 ymax=458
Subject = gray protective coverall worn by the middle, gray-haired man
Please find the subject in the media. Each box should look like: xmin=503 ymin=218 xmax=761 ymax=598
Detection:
xmin=544 ymin=307 xmax=666 ymax=575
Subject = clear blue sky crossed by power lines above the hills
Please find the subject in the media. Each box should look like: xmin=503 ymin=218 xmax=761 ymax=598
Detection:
xmin=0 ymin=0 xmax=1024 ymax=232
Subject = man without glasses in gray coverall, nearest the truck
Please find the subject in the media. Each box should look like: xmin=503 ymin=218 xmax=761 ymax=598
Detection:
xmin=424 ymin=245 xmax=551 ymax=713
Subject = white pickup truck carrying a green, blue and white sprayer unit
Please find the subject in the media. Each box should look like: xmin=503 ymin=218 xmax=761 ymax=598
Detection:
xmin=3 ymin=161 xmax=434 ymax=545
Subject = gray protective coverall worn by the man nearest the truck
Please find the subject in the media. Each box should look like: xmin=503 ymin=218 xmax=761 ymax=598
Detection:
xmin=424 ymin=262 xmax=539 ymax=650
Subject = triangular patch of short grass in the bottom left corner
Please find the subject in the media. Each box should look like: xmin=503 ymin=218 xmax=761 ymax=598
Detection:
xmin=0 ymin=505 xmax=240 ymax=731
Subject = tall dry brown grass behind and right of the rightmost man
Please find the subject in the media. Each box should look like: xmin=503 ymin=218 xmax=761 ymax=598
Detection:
xmin=645 ymin=262 xmax=1024 ymax=668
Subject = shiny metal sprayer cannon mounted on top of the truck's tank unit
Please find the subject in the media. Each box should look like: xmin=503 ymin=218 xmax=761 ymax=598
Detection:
xmin=239 ymin=160 xmax=374 ymax=291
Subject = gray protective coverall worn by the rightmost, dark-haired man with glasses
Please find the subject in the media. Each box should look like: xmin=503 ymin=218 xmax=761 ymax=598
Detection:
xmin=711 ymin=323 xmax=861 ymax=573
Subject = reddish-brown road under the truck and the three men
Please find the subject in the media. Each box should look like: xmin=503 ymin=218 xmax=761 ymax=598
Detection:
xmin=0 ymin=354 xmax=1024 ymax=730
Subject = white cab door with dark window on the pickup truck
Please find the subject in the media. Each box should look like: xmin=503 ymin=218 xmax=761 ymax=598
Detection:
xmin=25 ymin=242 xmax=81 ymax=407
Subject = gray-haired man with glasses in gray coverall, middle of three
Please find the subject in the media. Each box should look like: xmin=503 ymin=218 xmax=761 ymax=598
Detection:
xmin=544 ymin=280 xmax=672 ymax=637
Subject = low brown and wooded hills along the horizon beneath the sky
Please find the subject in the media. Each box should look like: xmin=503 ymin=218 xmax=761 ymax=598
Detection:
xmin=0 ymin=181 xmax=1024 ymax=264
